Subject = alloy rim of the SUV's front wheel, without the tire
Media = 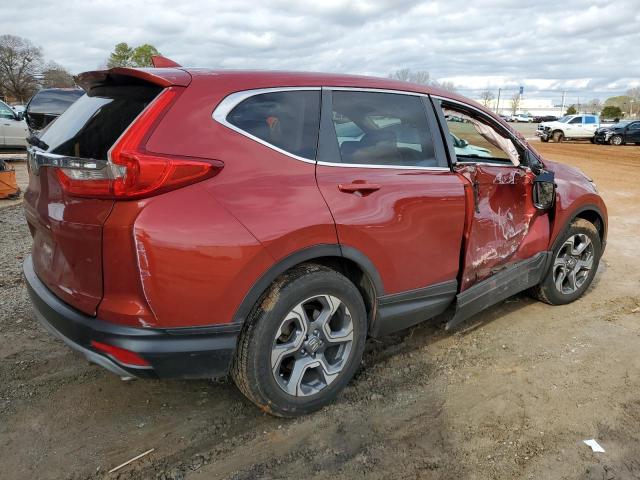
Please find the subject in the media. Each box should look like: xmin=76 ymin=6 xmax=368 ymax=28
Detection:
xmin=553 ymin=233 xmax=594 ymax=295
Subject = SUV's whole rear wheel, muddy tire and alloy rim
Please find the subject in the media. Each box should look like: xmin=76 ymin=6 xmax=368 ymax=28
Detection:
xmin=231 ymin=264 xmax=367 ymax=417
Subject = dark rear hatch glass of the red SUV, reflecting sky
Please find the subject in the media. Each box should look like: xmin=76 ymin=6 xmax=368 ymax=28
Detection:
xmin=40 ymin=85 xmax=161 ymax=160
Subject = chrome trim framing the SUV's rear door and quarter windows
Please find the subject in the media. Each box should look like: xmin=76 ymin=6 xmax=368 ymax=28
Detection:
xmin=211 ymin=86 xmax=451 ymax=172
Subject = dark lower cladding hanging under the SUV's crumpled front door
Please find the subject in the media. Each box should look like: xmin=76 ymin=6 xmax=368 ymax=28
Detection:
xmin=446 ymin=252 xmax=553 ymax=330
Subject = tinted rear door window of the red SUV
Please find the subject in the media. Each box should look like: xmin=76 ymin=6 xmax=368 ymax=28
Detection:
xmin=333 ymin=91 xmax=439 ymax=167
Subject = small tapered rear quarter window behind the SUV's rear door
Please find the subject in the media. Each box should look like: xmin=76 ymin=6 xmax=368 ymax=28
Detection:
xmin=227 ymin=91 xmax=320 ymax=159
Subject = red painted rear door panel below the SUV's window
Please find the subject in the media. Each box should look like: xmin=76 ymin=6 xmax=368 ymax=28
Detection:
xmin=317 ymin=165 xmax=465 ymax=294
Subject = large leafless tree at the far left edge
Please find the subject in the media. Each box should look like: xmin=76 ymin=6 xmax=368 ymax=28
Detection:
xmin=0 ymin=35 xmax=42 ymax=103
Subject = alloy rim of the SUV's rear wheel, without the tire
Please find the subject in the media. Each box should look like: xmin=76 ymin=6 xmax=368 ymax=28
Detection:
xmin=271 ymin=295 xmax=353 ymax=397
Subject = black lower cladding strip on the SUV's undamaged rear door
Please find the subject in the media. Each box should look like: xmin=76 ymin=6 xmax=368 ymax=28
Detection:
xmin=369 ymin=280 xmax=458 ymax=337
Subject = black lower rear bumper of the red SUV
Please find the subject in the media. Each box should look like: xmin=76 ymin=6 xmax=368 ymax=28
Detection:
xmin=23 ymin=256 xmax=241 ymax=378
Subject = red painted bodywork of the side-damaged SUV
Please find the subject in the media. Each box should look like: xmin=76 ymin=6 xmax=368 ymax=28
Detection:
xmin=25 ymin=68 xmax=606 ymax=327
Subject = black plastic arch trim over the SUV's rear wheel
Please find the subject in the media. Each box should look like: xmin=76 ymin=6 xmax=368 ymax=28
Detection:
xmin=233 ymin=244 xmax=384 ymax=325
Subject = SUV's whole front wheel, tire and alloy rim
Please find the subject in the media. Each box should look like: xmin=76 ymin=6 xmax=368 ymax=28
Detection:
xmin=530 ymin=218 xmax=602 ymax=305
